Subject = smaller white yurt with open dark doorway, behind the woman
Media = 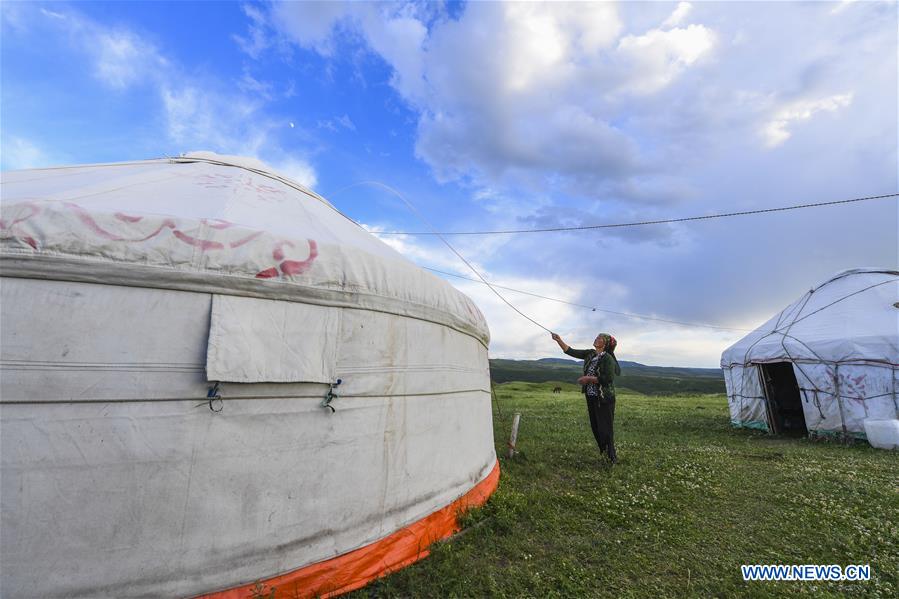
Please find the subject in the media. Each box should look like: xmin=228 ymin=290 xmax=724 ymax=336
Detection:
xmin=721 ymin=268 xmax=899 ymax=439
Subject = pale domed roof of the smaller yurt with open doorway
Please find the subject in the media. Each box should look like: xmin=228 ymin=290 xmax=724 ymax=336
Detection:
xmin=721 ymin=268 xmax=899 ymax=367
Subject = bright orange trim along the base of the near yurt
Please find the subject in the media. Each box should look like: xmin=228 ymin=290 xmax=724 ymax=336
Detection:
xmin=201 ymin=461 xmax=499 ymax=599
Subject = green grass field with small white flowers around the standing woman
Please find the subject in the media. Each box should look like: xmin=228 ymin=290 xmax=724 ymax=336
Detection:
xmin=351 ymin=383 xmax=899 ymax=598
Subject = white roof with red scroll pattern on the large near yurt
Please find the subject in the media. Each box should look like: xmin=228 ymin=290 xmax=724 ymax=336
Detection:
xmin=0 ymin=152 xmax=489 ymax=345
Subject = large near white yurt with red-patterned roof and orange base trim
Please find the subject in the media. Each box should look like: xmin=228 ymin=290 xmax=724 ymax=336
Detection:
xmin=0 ymin=152 xmax=499 ymax=599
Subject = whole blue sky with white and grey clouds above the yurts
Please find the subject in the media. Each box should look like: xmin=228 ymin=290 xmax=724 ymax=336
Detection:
xmin=0 ymin=1 xmax=899 ymax=367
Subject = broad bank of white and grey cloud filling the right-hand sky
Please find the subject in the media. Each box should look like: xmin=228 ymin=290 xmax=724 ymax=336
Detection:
xmin=241 ymin=2 xmax=896 ymax=366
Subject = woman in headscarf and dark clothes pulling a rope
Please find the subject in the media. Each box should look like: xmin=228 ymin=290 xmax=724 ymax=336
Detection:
xmin=552 ymin=333 xmax=621 ymax=464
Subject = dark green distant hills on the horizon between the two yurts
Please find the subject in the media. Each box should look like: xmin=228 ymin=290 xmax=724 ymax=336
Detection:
xmin=490 ymin=358 xmax=725 ymax=395
